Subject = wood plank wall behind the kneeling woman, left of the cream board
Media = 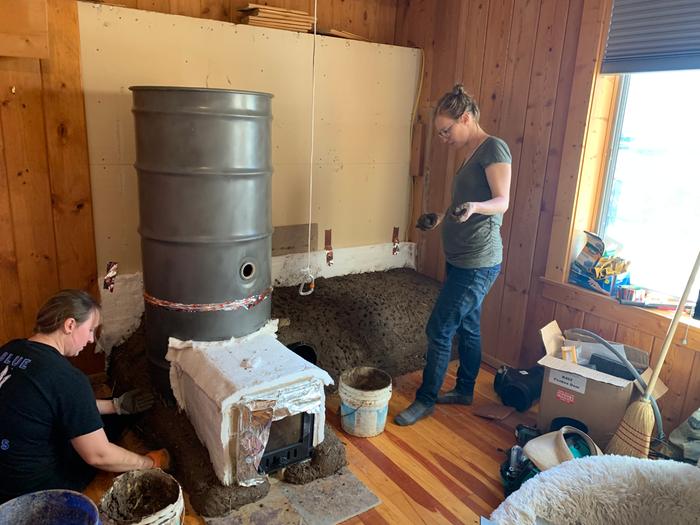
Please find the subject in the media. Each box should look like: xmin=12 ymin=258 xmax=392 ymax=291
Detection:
xmin=0 ymin=0 xmax=104 ymax=372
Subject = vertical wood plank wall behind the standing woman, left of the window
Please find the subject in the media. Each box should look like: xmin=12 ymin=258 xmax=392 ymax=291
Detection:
xmin=396 ymin=0 xmax=602 ymax=364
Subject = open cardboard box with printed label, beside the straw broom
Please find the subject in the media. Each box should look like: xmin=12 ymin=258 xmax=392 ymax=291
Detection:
xmin=537 ymin=321 xmax=667 ymax=449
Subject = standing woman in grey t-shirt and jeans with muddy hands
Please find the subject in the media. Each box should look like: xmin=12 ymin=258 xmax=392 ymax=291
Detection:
xmin=394 ymin=84 xmax=511 ymax=425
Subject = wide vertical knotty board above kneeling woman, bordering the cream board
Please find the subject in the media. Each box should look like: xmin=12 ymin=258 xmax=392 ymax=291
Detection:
xmin=41 ymin=0 xmax=98 ymax=295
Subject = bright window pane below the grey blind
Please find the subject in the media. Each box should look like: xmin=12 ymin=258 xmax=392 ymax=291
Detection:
xmin=598 ymin=70 xmax=700 ymax=301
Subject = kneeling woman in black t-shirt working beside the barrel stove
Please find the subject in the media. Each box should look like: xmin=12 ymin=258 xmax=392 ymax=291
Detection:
xmin=0 ymin=290 xmax=169 ymax=503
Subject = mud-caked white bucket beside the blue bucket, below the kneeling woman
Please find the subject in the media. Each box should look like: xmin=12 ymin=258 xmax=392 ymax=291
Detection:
xmin=100 ymin=469 xmax=185 ymax=525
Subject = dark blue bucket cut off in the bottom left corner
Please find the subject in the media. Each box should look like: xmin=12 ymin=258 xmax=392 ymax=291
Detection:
xmin=0 ymin=489 xmax=100 ymax=525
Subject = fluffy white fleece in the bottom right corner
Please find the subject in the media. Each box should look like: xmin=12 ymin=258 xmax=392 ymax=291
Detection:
xmin=491 ymin=456 xmax=700 ymax=525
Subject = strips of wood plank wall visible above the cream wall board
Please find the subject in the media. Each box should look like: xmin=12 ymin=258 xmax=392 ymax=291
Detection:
xmin=100 ymin=0 xmax=398 ymax=44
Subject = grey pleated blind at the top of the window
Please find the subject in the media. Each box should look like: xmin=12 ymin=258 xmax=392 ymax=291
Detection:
xmin=601 ymin=0 xmax=700 ymax=73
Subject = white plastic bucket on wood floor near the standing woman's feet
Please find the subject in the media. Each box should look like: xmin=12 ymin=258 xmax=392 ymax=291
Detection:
xmin=338 ymin=366 xmax=391 ymax=437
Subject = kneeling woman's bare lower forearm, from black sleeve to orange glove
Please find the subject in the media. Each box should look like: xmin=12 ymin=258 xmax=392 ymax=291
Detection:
xmin=71 ymin=428 xmax=154 ymax=472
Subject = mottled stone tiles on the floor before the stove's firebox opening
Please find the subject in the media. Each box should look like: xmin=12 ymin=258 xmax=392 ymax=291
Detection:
xmin=204 ymin=467 xmax=380 ymax=525
